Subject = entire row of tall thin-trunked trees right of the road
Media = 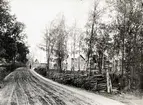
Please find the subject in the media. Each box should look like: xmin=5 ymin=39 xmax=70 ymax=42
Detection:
xmin=37 ymin=0 xmax=143 ymax=90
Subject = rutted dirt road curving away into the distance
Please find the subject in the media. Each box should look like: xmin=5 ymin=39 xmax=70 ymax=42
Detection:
xmin=0 ymin=68 xmax=124 ymax=105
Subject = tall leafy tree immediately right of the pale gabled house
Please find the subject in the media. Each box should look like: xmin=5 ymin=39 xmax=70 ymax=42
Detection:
xmin=85 ymin=2 xmax=112 ymax=73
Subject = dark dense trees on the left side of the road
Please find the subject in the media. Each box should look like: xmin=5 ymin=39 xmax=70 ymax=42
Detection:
xmin=0 ymin=0 xmax=29 ymax=79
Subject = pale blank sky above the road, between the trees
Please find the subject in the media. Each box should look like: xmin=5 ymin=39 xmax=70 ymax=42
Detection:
xmin=10 ymin=0 xmax=106 ymax=62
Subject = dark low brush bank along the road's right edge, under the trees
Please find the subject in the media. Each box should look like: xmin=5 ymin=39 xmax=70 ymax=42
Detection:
xmin=35 ymin=67 xmax=106 ymax=91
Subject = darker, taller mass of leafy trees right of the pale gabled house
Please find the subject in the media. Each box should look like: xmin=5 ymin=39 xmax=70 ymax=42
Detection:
xmin=82 ymin=0 xmax=143 ymax=89
